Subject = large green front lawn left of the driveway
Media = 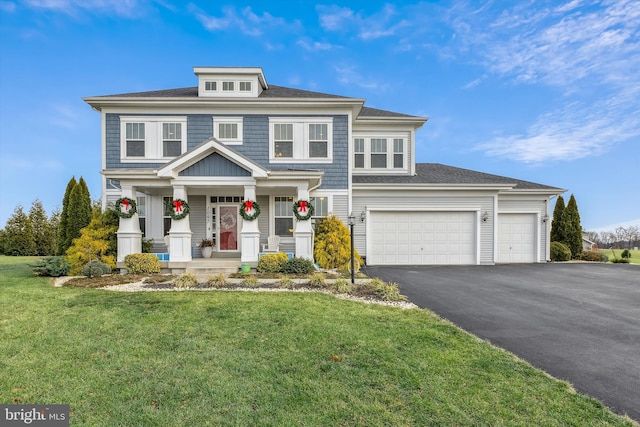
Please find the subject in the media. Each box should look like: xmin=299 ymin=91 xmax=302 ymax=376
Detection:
xmin=0 ymin=257 xmax=637 ymax=426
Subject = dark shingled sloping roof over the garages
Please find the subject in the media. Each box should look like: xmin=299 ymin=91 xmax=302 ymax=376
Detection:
xmin=352 ymin=163 xmax=565 ymax=194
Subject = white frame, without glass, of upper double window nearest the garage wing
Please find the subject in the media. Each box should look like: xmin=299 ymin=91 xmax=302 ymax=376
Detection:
xmin=269 ymin=117 xmax=333 ymax=163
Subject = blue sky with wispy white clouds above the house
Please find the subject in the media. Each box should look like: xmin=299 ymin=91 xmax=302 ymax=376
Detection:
xmin=0 ymin=0 xmax=640 ymax=230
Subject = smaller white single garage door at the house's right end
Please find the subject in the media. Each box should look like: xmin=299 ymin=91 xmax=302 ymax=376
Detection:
xmin=498 ymin=213 xmax=537 ymax=263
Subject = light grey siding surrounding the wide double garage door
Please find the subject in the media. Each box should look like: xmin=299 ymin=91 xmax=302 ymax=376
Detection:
xmin=353 ymin=190 xmax=495 ymax=264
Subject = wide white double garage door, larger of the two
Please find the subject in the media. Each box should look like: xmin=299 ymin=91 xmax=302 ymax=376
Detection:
xmin=367 ymin=211 xmax=476 ymax=265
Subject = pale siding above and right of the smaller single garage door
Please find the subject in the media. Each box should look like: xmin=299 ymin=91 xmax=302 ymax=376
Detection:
xmin=498 ymin=195 xmax=551 ymax=262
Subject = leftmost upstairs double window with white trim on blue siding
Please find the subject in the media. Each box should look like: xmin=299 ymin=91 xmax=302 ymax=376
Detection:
xmin=120 ymin=116 xmax=187 ymax=163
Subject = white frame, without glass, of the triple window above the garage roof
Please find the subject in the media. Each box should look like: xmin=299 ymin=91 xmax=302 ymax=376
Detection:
xmin=351 ymin=133 xmax=409 ymax=174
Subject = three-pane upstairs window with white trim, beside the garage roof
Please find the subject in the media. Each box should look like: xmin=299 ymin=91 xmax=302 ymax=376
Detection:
xmin=353 ymin=136 xmax=408 ymax=172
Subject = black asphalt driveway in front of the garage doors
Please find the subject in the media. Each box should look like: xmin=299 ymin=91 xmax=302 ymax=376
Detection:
xmin=366 ymin=263 xmax=640 ymax=421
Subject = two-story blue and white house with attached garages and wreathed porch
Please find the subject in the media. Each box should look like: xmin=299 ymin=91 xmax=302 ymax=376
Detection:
xmin=84 ymin=67 xmax=564 ymax=271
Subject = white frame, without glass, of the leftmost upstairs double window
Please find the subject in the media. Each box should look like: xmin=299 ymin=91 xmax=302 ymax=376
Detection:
xmin=120 ymin=116 xmax=187 ymax=163
